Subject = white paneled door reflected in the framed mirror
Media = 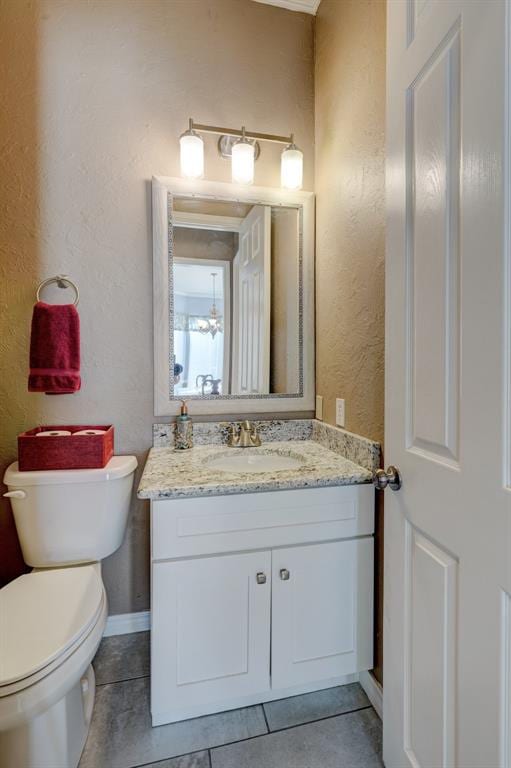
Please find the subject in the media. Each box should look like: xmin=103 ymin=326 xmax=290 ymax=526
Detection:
xmin=232 ymin=205 xmax=271 ymax=395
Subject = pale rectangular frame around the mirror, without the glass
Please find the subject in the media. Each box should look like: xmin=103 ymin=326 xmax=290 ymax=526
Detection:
xmin=152 ymin=176 xmax=315 ymax=417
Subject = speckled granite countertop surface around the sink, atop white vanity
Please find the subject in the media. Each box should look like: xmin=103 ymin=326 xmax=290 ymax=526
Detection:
xmin=138 ymin=440 xmax=372 ymax=499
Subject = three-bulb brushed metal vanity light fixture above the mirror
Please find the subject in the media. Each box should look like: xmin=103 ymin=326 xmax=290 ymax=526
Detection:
xmin=179 ymin=118 xmax=303 ymax=189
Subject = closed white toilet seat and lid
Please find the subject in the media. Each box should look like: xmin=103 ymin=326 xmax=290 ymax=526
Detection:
xmin=0 ymin=565 xmax=106 ymax=698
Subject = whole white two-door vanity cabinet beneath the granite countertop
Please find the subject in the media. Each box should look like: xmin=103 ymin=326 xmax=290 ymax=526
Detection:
xmin=151 ymin=485 xmax=374 ymax=725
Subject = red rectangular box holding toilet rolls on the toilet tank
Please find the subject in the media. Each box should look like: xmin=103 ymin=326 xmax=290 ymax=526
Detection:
xmin=18 ymin=424 xmax=114 ymax=472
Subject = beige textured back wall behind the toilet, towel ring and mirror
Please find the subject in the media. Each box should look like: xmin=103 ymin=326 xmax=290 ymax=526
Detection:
xmin=0 ymin=0 xmax=314 ymax=613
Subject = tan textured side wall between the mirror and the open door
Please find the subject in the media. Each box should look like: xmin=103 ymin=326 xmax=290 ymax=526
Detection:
xmin=315 ymin=0 xmax=385 ymax=440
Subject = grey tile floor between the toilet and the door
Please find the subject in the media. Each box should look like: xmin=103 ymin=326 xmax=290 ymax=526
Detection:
xmin=79 ymin=632 xmax=383 ymax=768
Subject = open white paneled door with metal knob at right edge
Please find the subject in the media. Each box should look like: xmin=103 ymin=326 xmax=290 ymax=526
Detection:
xmin=383 ymin=0 xmax=511 ymax=768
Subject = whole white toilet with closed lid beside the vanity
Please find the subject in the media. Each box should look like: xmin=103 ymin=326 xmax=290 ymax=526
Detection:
xmin=0 ymin=456 xmax=137 ymax=768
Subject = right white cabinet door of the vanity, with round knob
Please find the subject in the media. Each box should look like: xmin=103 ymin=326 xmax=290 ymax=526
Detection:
xmin=272 ymin=538 xmax=373 ymax=689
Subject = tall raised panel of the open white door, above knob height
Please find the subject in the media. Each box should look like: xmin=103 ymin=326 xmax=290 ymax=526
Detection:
xmin=406 ymin=24 xmax=461 ymax=464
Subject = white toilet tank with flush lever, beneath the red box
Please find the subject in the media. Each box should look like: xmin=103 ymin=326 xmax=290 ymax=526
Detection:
xmin=4 ymin=456 xmax=137 ymax=568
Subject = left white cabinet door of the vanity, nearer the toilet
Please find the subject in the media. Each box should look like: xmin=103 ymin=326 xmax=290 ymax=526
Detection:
xmin=151 ymin=552 xmax=271 ymax=725
